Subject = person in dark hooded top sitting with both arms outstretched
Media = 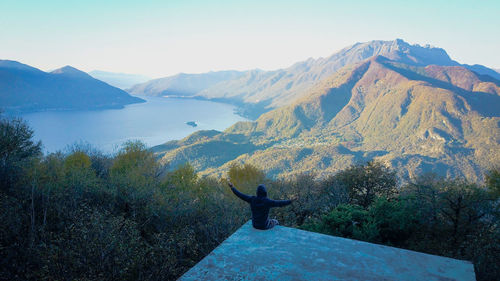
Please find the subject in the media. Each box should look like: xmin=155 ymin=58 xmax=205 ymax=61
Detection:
xmin=228 ymin=182 xmax=292 ymax=230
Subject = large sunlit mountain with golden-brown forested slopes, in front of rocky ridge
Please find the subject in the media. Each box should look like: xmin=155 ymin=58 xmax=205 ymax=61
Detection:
xmin=153 ymin=56 xmax=500 ymax=181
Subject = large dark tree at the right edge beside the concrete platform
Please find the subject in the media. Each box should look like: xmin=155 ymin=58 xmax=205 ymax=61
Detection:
xmin=401 ymin=174 xmax=500 ymax=280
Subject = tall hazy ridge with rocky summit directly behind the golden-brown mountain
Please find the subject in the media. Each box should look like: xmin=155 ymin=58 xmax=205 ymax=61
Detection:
xmin=199 ymin=39 xmax=458 ymax=109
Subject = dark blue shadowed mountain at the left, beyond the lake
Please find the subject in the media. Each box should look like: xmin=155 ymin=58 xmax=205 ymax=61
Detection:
xmin=0 ymin=60 xmax=144 ymax=112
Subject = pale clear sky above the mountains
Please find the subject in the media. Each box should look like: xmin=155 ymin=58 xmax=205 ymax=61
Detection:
xmin=0 ymin=0 xmax=500 ymax=78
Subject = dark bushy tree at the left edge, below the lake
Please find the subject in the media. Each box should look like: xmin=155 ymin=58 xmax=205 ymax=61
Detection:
xmin=0 ymin=117 xmax=41 ymax=190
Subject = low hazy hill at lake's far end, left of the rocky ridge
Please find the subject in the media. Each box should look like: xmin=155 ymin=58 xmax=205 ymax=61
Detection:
xmin=128 ymin=70 xmax=248 ymax=96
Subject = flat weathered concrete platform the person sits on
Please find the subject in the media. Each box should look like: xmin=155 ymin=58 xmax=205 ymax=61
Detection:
xmin=179 ymin=222 xmax=476 ymax=281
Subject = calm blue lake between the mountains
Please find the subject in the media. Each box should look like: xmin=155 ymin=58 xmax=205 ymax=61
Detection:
xmin=15 ymin=97 xmax=246 ymax=152
